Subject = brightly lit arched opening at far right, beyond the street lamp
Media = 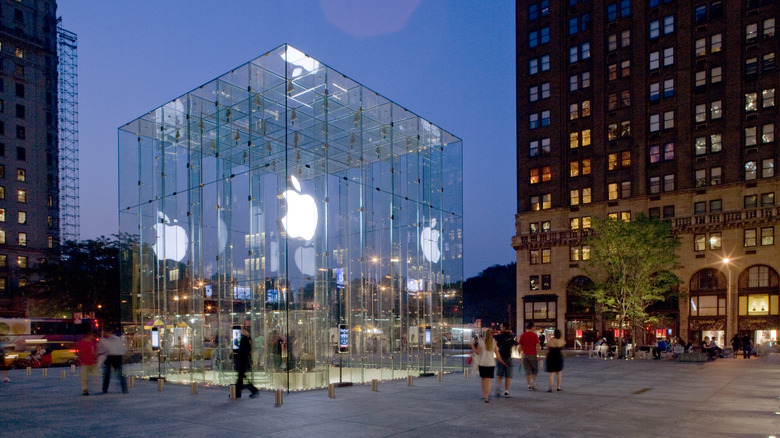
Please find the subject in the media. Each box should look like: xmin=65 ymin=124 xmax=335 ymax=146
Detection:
xmin=737 ymin=265 xmax=780 ymax=350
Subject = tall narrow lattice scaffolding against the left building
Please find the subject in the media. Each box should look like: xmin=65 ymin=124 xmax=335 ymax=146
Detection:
xmin=57 ymin=18 xmax=80 ymax=242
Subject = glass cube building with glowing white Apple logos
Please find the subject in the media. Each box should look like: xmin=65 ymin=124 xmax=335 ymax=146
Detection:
xmin=118 ymin=45 xmax=469 ymax=390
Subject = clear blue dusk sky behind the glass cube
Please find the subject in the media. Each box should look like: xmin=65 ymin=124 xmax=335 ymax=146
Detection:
xmin=57 ymin=0 xmax=517 ymax=278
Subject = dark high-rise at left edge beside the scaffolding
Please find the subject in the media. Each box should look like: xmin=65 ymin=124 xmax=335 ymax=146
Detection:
xmin=0 ymin=0 xmax=59 ymax=313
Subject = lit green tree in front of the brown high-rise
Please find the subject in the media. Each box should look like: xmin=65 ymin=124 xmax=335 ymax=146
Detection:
xmin=581 ymin=213 xmax=680 ymax=351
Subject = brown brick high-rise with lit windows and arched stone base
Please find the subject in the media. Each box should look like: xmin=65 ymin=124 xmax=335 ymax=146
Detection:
xmin=512 ymin=0 xmax=780 ymax=345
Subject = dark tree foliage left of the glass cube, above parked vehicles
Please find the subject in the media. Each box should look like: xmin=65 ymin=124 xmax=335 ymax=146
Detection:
xmin=25 ymin=236 xmax=120 ymax=323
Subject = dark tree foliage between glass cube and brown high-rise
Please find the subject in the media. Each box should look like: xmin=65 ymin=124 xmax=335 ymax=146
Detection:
xmin=463 ymin=263 xmax=517 ymax=325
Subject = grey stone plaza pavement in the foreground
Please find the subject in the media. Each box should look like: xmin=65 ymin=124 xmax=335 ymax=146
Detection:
xmin=0 ymin=357 xmax=780 ymax=438
